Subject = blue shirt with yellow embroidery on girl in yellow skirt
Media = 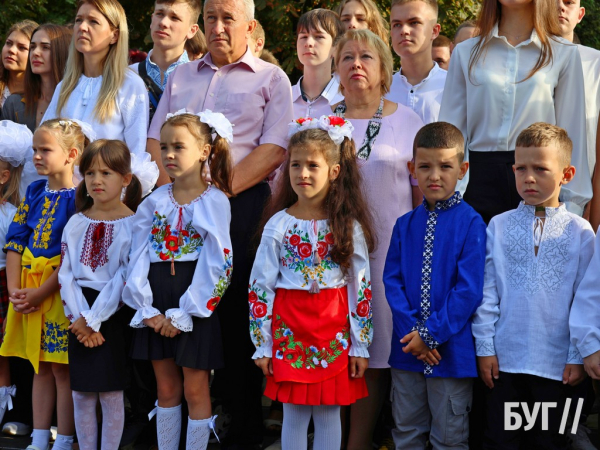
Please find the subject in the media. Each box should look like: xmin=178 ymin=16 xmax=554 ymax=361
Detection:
xmin=4 ymin=180 xmax=75 ymax=259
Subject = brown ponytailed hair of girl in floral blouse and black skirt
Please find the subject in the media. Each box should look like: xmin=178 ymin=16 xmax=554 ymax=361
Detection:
xmin=161 ymin=114 xmax=233 ymax=195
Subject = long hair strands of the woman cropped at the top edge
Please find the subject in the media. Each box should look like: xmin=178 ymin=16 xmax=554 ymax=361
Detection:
xmin=469 ymin=0 xmax=560 ymax=83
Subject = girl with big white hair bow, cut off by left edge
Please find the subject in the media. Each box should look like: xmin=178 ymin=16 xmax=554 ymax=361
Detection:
xmin=0 ymin=120 xmax=32 ymax=423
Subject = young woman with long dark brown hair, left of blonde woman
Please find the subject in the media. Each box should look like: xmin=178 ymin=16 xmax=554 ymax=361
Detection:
xmin=2 ymin=23 xmax=73 ymax=132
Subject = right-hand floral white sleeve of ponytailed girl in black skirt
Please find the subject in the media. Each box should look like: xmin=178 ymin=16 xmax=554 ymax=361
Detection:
xmin=165 ymin=192 xmax=233 ymax=331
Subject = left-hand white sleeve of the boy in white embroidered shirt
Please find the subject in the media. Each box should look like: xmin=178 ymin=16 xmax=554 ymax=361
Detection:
xmin=471 ymin=219 xmax=500 ymax=356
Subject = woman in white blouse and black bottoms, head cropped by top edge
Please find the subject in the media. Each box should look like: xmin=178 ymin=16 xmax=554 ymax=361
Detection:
xmin=439 ymin=0 xmax=592 ymax=223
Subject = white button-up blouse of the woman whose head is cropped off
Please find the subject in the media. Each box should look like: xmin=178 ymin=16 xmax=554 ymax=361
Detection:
xmin=439 ymin=25 xmax=592 ymax=215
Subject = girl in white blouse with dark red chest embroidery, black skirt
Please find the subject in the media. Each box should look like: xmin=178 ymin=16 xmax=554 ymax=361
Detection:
xmin=58 ymin=139 xmax=149 ymax=450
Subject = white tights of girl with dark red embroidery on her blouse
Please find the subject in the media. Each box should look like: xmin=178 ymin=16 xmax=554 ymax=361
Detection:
xmin=73 ymin=391 xmax=125 ymax=450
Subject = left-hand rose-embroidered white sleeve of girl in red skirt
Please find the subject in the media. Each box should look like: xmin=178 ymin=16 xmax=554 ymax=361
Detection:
xmin=248 ymin=229 xmax=283 ymax=359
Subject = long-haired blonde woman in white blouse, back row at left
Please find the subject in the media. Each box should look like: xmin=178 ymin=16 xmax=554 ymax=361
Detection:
xmin=42 ymin=0 xmax=149 ymax=154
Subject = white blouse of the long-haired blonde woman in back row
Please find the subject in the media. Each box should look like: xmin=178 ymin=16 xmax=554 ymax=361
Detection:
xmin=42 ymin=68 xmax=150 ymax=154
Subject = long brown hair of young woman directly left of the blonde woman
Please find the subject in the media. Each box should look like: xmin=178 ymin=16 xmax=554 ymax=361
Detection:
xmin=24 ymin=23 xmax=73 ymax=115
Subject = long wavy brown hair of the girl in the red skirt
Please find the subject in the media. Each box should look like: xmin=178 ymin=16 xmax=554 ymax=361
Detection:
xmin=259 ymin=129 xmax=376 ymax=270
